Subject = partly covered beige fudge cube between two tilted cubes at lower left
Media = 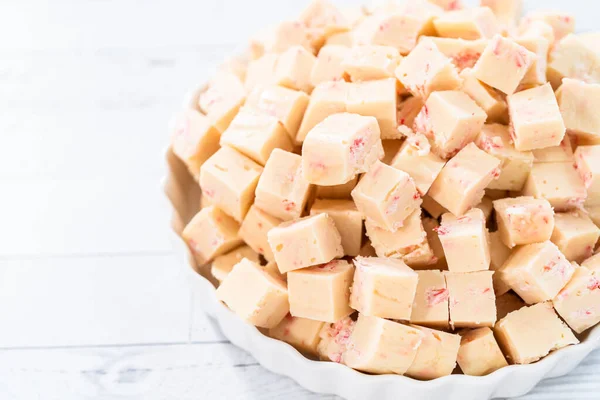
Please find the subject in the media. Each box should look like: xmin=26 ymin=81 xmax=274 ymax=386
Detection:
xmin=238 ymin=205 xmax=282 ymax=261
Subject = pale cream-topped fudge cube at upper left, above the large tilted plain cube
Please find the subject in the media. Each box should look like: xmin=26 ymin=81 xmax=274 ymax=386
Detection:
xmin=220 ymin=108 xmax=293 ymax=165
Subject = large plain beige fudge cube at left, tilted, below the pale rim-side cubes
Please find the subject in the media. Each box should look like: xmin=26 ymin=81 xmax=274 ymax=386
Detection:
xmin=200 ymin=146 xmax=263 ymax=222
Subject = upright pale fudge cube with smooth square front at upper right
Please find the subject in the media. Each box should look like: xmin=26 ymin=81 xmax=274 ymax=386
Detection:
xmin=507 ymin=83 xmax=566 ymax=151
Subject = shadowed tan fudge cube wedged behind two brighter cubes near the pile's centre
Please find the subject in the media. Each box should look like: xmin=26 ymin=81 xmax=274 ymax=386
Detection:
xmin=310 ymin=199 xmax=363 ymax=257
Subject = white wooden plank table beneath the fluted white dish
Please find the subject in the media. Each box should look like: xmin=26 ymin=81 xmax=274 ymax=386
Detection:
xmin=0 ymin=0 xmax=600 ymax=400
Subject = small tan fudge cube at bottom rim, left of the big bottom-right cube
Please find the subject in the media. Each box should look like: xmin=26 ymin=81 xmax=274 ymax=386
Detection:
xmin=457 ymin=327 xmax=508 ymax=376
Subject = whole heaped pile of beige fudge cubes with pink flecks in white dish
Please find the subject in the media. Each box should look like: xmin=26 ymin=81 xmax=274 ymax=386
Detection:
xmin=171 ymin=0 xmax=600 ymax=379
